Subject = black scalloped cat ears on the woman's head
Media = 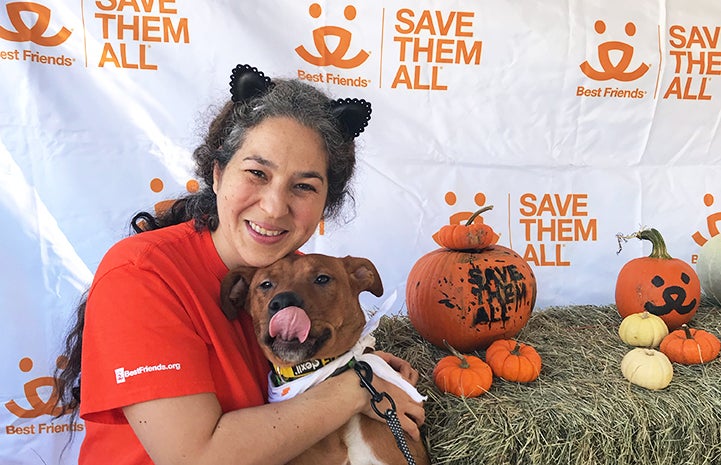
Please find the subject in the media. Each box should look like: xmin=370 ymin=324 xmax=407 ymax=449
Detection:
xmin=230 ymin=65 xmax=371 ymax=140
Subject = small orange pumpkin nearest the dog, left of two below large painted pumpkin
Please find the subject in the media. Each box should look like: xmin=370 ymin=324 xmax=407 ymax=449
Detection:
xmin=433 ymin=341 xmax=493 ymax=397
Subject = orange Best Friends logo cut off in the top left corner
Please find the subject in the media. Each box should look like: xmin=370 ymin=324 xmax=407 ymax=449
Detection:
xmin=0 ymin=2 xmax=75 ymax=66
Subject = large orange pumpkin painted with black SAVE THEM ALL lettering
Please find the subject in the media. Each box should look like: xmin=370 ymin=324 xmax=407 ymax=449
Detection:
xmin=406 ymin=212 xmax=536 ymax=352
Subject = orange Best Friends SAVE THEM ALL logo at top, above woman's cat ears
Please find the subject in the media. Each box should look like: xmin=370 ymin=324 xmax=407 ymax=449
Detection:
xmin=294 ymin=3 xmax=483 ymax=91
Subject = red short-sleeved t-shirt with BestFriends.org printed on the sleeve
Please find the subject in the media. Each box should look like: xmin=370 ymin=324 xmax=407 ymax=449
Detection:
xmin=79 ymin=222 xmax=269 ymax=465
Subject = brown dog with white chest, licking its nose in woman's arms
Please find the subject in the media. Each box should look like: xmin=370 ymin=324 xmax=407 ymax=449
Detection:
xmin=220 ymin=254 xmax=430 ymax=465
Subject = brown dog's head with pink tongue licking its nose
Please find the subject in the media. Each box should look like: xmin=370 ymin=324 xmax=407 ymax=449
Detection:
xmin=220 ymin=254 xmax=383 ymax=366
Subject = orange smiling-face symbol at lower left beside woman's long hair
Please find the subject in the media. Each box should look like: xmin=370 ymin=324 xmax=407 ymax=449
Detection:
xmin=5 ymin=356 xmax=69 ymax=418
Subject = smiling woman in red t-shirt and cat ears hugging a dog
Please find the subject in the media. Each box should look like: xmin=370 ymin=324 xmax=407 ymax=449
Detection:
xmin=59 ymin=65 xmax=424 ymax=465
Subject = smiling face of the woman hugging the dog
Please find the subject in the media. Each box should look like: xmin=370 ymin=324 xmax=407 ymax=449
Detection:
xmin=212 ymin=117 xmax=328 ymax=268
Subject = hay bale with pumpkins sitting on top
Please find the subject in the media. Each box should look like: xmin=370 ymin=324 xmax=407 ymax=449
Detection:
xmin=375 ymin=301 xmax=721 ymax=465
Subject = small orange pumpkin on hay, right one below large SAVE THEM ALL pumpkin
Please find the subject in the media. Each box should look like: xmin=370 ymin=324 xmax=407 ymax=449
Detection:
xmin=486 ymin=339 xmax=541 ymax=383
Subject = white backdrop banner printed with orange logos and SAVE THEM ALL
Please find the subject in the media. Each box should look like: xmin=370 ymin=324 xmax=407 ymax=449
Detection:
xmin=0 ymin=0 xmax=721 ymax=465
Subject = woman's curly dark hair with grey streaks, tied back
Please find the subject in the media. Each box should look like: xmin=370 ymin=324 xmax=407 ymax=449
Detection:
xmin=55 ymin=79 xmax=356 ymax=428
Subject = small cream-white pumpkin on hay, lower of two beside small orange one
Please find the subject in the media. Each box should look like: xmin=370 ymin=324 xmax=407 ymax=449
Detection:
xmin=621 ymin=347 xmax=673 ymax=390
